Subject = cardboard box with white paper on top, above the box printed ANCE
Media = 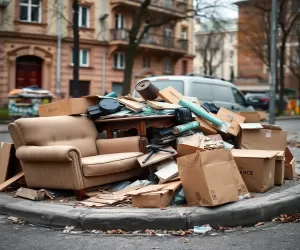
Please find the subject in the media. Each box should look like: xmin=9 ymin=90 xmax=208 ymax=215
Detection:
xmin=237 ymin=123 xmax=287 ymax=151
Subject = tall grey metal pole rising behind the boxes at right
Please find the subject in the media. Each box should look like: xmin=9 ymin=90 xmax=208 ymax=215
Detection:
xmin=269 ymin=0 xmax=278 ymax=124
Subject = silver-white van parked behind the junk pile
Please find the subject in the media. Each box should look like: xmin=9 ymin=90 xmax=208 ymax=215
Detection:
xmin=132 ymin=76 xmax=255 ymax=112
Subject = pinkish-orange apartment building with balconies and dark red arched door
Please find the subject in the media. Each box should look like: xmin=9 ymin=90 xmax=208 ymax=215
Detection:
xmin=0 ymin=0 xmax=194 ymax=103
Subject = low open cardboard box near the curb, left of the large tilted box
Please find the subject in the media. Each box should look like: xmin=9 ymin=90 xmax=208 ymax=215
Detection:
xmin=131 ymin=181 xmax=181 ymax=208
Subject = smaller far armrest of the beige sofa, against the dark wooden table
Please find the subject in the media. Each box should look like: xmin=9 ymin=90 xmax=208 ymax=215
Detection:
xmin=96 ymin=136 xmax=142 ymax=155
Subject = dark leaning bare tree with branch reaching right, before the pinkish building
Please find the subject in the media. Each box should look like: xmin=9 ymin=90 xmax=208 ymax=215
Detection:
xmin=122 ymin=0 xmax=222 ymax=95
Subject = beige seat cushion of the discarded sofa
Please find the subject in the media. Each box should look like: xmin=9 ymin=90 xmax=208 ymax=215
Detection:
xmin=82 ymin=152 xmax=143 ymax=177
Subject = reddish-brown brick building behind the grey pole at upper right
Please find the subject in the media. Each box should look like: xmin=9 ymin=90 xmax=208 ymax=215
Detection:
xmin=235 ymin=0 xmax=300 ymax=99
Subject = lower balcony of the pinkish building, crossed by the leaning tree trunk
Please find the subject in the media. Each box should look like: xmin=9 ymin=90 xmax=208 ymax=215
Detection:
xmin=110 ymin=29 xmax=188 ymax=54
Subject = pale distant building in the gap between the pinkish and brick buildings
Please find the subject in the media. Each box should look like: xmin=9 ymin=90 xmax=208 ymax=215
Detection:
xmin=193 ymin=19 xmax=238 ymax=81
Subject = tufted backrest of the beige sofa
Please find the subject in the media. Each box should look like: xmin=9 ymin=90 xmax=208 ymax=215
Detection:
xmin=9 ymin=116 xmax=98 ymax=157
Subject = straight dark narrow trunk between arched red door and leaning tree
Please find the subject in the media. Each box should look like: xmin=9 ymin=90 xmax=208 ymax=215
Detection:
xmin=73 ymin=0 xmax=79 ymax=94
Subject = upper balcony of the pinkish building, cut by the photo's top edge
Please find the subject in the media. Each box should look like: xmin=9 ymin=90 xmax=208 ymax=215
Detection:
xmin=110 ymin=0 xmax=189 ymax=17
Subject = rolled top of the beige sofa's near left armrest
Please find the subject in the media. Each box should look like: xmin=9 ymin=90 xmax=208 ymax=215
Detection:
xmin=16 ymin=145 xmax=81 ymax=162
